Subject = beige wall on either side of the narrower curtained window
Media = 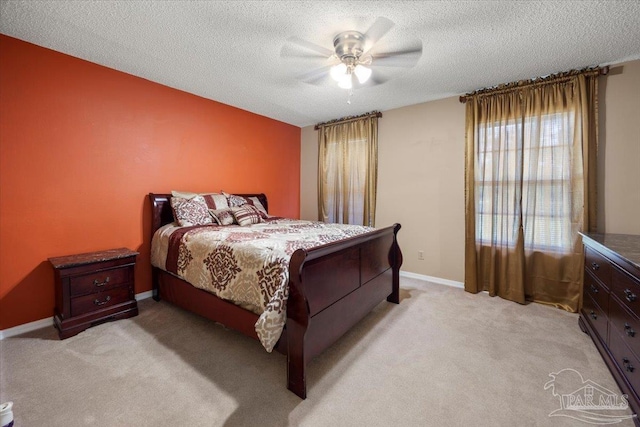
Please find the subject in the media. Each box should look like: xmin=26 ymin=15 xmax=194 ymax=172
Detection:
xmin=300 ymin=98 xmax=464 ymax=281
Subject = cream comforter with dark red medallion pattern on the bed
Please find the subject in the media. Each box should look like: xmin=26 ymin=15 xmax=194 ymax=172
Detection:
xmin=151 ymin=218 xmax=374 ymax=352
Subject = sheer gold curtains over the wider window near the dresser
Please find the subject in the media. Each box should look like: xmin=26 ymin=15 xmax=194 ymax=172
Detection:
xmin=461 ymin=69 xmax=603 ymax=312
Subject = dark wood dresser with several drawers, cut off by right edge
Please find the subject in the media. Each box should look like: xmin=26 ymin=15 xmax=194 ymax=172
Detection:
xmin=579 ymin=233 xmax=640 ymax=425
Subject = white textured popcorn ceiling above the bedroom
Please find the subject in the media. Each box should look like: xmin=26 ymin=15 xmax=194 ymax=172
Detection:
xmin=0 ymin=0 xmax=640 ymax=127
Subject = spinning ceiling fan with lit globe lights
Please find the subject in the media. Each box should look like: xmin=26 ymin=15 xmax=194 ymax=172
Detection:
xmin=280 ymin=17 xmax=422 ymax=90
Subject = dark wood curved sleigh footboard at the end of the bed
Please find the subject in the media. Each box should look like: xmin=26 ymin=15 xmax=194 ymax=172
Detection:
xmin=285 ymin=224 xmax=402 ymax=399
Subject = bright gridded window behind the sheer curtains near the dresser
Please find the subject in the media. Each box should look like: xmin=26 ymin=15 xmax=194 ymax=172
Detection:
xmin=475 ymin=113 xmax=582 ymax=252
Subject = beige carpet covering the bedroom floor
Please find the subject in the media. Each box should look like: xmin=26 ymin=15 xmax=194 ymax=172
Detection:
xmin=0 ymin=278 xmax=633 ymax=427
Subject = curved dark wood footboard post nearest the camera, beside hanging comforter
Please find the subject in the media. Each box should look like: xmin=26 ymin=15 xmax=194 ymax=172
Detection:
xmin=285 ymin=249 xmax=309 ymax=399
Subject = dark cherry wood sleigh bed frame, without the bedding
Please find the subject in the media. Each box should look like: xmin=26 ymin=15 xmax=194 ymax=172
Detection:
xmin=149 ymin=193 xmax=402 ymax=399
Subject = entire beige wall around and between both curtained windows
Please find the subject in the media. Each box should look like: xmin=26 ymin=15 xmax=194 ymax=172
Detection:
xmin=300 ymin=61 xmax=640 ymax=282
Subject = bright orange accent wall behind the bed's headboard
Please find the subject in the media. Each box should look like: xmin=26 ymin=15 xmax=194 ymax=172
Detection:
xmin=0 ymin=35 xmax=300 ymax=330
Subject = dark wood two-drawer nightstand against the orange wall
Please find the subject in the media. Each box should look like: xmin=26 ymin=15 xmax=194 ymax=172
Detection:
xmin=49 ymin=248 xmax=138 ymax=339
